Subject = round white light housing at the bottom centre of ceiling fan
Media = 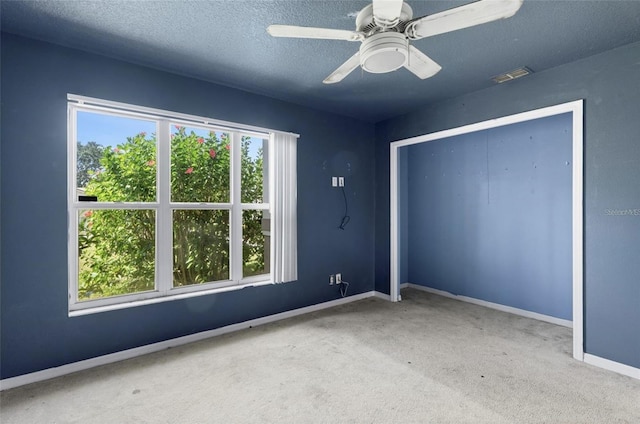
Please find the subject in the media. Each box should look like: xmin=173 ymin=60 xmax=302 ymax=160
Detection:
xmin=360 ymin=32 xmax=409 ymax=74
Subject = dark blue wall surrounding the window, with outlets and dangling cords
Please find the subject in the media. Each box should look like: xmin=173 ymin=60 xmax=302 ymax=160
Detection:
xmin=0 ymin=34 xmax=374 ymax=378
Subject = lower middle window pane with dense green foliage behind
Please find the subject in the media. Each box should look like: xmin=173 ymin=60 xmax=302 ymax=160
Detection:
xmin=173 ymin=210 xmax=229 ymax=287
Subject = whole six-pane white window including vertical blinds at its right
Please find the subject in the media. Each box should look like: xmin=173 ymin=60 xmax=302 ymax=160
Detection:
xmin=69 ymin=95 xmax=297 ymax=311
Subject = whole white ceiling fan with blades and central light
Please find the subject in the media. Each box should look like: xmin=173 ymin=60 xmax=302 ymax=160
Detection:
xmin=267 ymin=0 xmax=523 ymax=84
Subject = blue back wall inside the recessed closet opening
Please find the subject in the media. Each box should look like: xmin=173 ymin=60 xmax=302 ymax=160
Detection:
xmin=400 ymin=114 xmax=572 ymax=320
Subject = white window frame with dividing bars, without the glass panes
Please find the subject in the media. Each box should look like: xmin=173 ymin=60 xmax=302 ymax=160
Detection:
xmin=67 ymin=94 xmax=298 ymax=316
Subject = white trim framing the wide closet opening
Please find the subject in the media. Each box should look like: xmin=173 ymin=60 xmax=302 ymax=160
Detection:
xmin=390 ymin=100 xmax=584 ymax=361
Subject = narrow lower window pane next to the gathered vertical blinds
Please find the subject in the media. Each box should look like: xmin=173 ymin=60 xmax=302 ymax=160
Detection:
xmin=242 ymin=210 xmax=271 ymax=277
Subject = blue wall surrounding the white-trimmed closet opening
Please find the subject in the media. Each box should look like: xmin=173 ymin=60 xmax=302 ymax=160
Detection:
xmin=375 ymin=43 xmax=640 ymax=367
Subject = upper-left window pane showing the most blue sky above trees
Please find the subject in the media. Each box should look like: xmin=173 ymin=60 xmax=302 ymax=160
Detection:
xmin=76 ymin=111 xmax=156 ymax=202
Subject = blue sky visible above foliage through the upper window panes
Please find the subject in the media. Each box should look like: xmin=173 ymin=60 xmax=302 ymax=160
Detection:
xmin=77 ymin=111 xmax=262 ymax=158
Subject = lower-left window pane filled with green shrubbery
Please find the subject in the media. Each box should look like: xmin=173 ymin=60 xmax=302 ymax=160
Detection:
xmin=78 ymin=209 xmax=156 ymax=301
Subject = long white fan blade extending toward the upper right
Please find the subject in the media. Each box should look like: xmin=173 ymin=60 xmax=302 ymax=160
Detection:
xmin=405 ymin=0 xmax=522 ymax=40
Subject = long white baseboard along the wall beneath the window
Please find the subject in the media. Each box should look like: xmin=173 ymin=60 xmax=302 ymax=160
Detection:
xmin=0 ymin=291 xmax=382 ymax=391
